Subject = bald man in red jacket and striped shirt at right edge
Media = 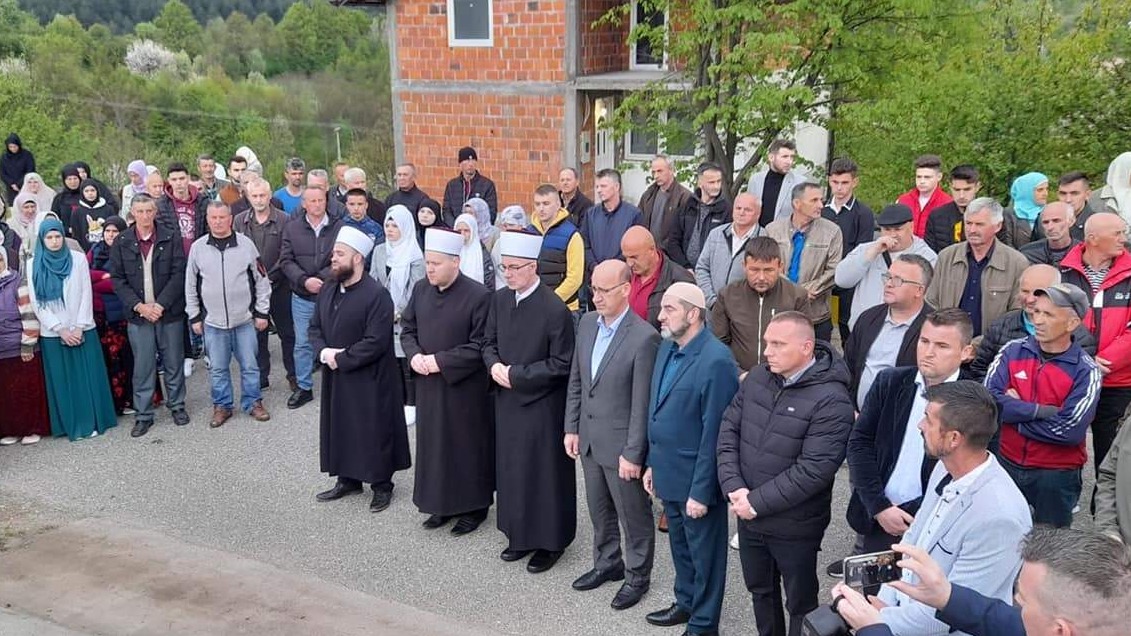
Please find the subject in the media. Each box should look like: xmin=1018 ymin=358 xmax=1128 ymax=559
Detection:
xmin=1060 ymin=212 xmax=1131 ymax=510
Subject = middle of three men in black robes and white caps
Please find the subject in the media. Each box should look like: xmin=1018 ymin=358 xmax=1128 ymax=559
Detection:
xmin=400 ymin=229 xmax=494 ymax=536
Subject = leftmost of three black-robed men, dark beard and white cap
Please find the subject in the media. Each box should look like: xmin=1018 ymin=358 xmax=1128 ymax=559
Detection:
xmin=310 ymin=227 xmax=412 ymax=513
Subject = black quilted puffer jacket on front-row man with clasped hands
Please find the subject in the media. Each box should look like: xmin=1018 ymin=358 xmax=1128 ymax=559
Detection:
xmin=718 ymin=342 xmax=853 ymax=539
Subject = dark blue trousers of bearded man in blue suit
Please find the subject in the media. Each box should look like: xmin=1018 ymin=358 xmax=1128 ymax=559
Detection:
xmin=664 ymin=500 xmax=727 ymax=631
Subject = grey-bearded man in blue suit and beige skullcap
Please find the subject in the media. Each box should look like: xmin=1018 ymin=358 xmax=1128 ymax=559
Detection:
xmin=644 ymin=283 xmax=739 ymax=636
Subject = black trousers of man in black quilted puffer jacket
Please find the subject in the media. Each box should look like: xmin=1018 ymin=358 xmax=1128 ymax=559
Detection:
xmin=739 ymin=519 xmax=821 ymax=636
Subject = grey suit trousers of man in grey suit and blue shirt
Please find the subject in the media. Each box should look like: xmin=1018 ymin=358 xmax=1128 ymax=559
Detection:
xmin=581 ymin=453 xmax=656 ymax=585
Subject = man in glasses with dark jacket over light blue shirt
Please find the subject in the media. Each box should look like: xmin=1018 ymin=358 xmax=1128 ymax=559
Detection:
xmin=845 ymin=253 xmax=933 ymax=411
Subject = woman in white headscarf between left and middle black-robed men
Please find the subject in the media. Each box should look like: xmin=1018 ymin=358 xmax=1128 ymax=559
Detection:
xmin=369 ymin=205 xmax=424 ymax=424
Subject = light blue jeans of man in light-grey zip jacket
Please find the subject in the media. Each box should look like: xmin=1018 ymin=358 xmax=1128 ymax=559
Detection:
xmin=205 ymin=321 xmax=260 ymax=411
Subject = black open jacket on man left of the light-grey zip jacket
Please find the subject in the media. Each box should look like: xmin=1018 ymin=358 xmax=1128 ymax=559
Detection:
xmin=110 ymin=225 xmax=184 ymax=325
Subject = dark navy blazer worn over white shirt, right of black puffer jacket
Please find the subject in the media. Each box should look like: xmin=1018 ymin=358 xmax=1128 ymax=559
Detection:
xmin=845 ymin=362 xmax=936 ymax=534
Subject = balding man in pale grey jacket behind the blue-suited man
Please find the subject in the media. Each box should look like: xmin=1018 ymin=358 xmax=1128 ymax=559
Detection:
xmin=696 ymin=192 xmax=762 ymax=309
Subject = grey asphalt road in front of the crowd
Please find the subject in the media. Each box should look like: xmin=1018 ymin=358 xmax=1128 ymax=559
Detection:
xmin=0 ymin=338 xmax=1091 ymax=636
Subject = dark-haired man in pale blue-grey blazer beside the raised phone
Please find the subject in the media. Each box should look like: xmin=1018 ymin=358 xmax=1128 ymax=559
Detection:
xmin=879 ymin=380 xmax=1033 ymax=636
